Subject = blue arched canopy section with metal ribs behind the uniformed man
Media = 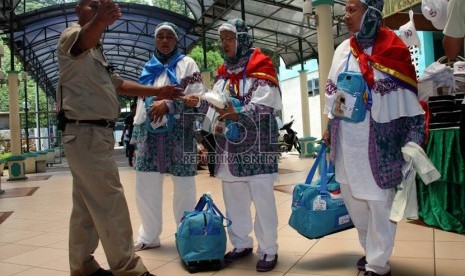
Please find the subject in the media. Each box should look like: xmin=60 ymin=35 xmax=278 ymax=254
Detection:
xmin=6 ymin=3 xmax=199 ymax=98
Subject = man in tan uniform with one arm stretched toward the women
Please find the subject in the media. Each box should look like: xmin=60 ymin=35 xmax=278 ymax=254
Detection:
xmin=57 ymin=0 xmax=181 ymax=276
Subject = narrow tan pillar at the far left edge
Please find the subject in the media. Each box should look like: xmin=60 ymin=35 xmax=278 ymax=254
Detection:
xmin=8 ymin=71 xmax=21 ymax=155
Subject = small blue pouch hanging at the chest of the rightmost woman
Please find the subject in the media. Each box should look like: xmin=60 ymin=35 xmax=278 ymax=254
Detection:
xmin=331 ymin=53 xmax=371 ymax=123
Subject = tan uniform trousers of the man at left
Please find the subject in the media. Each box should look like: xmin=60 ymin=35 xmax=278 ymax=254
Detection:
xmin=62 ymin=124 xmax=147 ymax=276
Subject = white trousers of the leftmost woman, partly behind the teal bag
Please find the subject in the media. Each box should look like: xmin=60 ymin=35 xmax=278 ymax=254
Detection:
xmin=136 ymin=171 xmax=197 ymax=244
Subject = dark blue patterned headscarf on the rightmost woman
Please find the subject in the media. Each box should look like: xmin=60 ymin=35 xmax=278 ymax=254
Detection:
xmin=355 ymin=0 xmax=384 ymax=48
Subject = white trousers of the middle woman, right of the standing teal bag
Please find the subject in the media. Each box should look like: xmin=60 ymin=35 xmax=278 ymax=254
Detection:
xmin=222 ymin=175 xmax=278 ymax=258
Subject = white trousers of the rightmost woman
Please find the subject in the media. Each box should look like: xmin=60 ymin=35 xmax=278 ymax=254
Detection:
xmin=340 ymin=183 xmax=397 ymax=275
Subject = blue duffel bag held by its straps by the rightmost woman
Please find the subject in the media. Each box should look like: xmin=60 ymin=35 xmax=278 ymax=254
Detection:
xmin=289 ymin=144 xmax=354 ymax=239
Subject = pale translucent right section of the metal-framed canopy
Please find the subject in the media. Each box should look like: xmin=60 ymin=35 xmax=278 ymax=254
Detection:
xmin=185 ymin=0 xmax=348 ymax=67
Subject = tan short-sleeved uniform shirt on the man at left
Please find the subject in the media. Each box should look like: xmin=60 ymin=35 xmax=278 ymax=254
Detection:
xmin=57 ymin=24 xmax=123 ymax=120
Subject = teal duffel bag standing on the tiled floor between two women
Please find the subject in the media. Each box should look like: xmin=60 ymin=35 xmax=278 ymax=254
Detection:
xmin=175 ymin=194 xmax=231 ymax=272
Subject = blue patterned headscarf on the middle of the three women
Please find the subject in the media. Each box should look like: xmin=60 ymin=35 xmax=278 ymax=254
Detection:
xmin=218 ymin=19 xmax=252 ymax=65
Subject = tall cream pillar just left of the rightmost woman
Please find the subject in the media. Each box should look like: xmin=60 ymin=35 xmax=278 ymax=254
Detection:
xmin=312 ymin=0 xmax=334 ymax=136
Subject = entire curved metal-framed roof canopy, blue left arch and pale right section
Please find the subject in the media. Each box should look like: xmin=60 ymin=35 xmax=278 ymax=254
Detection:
xmin=0 ymin=0 xmax=347 ymax=101
